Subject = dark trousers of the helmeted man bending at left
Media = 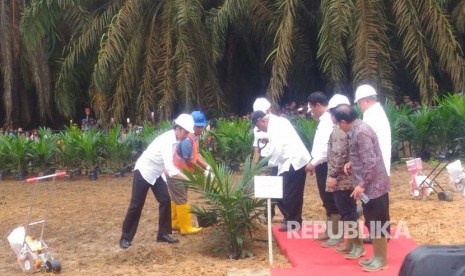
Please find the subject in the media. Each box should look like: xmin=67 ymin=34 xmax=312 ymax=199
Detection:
xmin=121 ymin=170 xmax=172 ymax=241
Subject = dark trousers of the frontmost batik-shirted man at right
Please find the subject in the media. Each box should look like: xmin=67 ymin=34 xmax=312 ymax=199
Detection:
xmin=362 ymin=193 xmax=391 ymax=238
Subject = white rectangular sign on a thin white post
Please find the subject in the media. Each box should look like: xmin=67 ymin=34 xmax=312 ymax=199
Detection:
xmin=254 ymin=176 xmax=283 ymax=266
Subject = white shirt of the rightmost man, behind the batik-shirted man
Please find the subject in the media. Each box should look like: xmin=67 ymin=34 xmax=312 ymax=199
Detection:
xmin=363 ymin=103 xmax=391 ymax=175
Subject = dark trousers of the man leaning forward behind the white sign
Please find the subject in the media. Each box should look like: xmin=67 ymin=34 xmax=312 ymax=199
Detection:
xmin=278 ymin=166 xmax=307 ymax=223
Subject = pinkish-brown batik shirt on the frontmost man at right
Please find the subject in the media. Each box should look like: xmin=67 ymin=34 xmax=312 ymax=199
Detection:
xmin=348 ymin=119 xmax=391 ymax=199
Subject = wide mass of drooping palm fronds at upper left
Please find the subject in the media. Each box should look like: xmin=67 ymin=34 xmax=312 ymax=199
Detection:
xmin=23 ymin=0 xmax=223 ymax=121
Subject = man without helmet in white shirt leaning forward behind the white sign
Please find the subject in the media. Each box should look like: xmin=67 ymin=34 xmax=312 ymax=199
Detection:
xmin=251 ymin=111 xmax=310 ymax=232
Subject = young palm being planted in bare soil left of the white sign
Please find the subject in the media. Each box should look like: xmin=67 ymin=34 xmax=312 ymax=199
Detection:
xmin=185 ymin=153 xmax=268 ymax=259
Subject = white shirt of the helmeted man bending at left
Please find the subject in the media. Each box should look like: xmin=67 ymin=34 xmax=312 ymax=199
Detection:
xmin=134 ymin=129 xmax=179 ymax=185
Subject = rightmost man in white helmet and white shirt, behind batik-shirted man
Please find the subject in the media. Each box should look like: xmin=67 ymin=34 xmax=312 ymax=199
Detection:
xmin=354 ymin=84 xmax=391 ymax=176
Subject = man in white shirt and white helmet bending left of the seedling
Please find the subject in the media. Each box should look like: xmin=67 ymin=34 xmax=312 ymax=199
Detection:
xmin=119 ymin=114 xmax=194 ymax=249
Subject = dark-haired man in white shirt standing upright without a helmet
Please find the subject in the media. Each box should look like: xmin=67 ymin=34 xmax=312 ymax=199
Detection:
xmin=306 ymin=91 xmax=340 ymax=241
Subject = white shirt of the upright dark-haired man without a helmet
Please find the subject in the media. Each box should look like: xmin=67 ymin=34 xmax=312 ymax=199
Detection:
xmin=310 ymin=111 xmax=334 ymax=167
